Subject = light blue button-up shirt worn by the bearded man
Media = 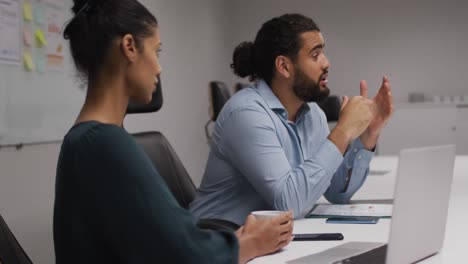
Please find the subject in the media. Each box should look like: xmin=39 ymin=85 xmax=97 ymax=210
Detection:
xmin=190 ymin=80 xmax=373 ymax=225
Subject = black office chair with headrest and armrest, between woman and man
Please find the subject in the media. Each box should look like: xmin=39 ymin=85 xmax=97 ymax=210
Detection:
xmin=127 ymin=76 xmax=239 ymax=231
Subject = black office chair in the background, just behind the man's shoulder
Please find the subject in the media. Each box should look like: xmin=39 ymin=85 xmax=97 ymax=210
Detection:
xmin=205 ymin=81 xmax=231 ymax=142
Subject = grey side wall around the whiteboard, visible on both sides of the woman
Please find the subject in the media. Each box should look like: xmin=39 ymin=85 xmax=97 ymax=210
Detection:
xmin=0 ymin=0 xmax=232 ymax=264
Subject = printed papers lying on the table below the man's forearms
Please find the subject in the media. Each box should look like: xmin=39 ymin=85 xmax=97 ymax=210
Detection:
xmin=306 ymin=204 xmax=393 ymax=218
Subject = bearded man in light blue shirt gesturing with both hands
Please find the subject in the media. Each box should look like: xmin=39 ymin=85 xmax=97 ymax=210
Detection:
xmin=190 ymin=14 xmax=393 ymax=225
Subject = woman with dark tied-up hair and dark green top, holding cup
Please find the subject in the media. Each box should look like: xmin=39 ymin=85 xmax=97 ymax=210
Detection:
xmin=54 ymin=0 xmax=293 ymax=264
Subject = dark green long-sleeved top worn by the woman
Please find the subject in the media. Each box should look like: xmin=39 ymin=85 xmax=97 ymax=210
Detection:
xmin=54 ymin=121 xmax=238 ymax=264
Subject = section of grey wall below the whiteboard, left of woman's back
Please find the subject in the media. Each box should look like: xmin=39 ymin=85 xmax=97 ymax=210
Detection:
xmin=0 ymin=144 xmax=60 ymax=264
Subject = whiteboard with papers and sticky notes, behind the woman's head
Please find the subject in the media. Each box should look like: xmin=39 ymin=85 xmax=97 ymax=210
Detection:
xmin=0 ymin=0 xmax=85 ymax=145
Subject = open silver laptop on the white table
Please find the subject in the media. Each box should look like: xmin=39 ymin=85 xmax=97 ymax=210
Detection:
xmin=288 ymin=145 xmax=455 ymax=264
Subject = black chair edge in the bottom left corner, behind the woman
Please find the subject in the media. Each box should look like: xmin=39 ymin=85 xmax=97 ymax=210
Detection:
xmin=0 ymin=215 xmax=32 ymax=264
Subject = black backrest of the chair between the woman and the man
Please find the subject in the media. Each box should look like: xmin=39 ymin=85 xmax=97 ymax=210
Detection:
xmin=133 ymin=131 xmax=196 ymax=209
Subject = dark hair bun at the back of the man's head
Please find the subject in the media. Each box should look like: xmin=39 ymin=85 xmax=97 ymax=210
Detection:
xmin=231 ymin=41 xmax=255 ymax=78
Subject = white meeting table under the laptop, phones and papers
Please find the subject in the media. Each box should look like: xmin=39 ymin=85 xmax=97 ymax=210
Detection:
xmin=250 ymin=156 xmax=468 ymax=264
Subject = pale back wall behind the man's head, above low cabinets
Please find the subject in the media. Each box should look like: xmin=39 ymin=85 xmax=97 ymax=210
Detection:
xmin=226 ymin=0 xmax=468 ymax=101
